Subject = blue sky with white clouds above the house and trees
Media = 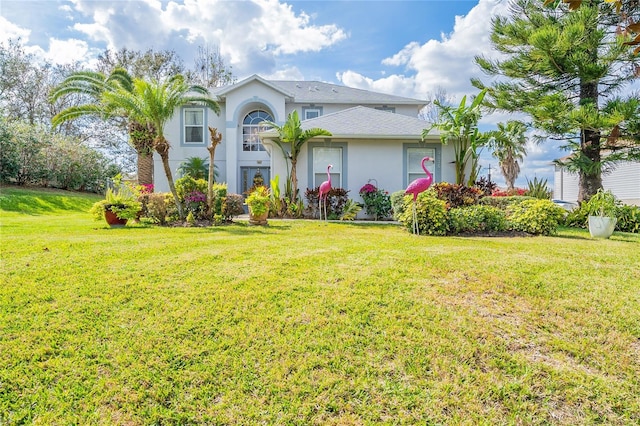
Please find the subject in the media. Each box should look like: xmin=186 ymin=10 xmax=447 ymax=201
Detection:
xmin=0 ymin=0 xmax=566 ymax=187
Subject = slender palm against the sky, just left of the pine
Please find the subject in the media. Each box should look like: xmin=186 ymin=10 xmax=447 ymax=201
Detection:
xmin=489 ymin=121 xmax=527 ymax=191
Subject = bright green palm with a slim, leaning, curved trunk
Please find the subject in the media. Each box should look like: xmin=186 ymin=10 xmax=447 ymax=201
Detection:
xmin=103 ymin=74 xmax=220 ymax=219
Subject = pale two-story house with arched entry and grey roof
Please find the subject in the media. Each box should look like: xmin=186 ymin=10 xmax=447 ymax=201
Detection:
xmin=154 ymin=75 xmax=455 ymax=200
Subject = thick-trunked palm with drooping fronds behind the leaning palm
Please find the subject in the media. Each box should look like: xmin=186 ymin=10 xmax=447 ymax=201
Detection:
xmin=50 ymin=68 xmax=155 ymax=185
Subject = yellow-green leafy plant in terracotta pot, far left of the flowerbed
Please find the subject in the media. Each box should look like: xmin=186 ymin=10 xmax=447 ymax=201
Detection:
xmin=89 ymin=179 xmax=142 ymax=227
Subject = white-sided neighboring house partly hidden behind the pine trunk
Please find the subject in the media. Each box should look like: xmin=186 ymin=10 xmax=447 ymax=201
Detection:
xmin=553 ymin=162 xmax=640 ymax=206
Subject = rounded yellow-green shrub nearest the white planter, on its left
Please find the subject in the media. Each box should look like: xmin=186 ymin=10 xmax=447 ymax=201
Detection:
xmin=507 ymin=199 xmax=566 ymax=235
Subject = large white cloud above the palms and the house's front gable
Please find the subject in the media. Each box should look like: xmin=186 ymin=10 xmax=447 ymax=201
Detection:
xmin=67 ymin=0 xmax=347 ymax=75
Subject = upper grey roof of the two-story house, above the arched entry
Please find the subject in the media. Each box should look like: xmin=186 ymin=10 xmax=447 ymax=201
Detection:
xmin=212 ymin=74 xmax=427 ymax=108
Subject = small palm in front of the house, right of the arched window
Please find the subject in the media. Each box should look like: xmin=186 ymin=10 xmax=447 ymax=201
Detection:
xmin=263 ymin=110 xmax=332 ymax=203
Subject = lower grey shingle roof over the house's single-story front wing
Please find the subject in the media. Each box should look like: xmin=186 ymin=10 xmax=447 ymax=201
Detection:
xmin=260 ymin=106 xmax=439 ymax=140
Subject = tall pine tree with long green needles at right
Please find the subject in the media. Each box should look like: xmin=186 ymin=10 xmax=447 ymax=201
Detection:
xmin=473 ymin=0 xmax=640 ymax=200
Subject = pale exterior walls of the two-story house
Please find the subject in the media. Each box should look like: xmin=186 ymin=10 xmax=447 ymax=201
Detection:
xmin=154 ymin=81 xmax=428 ymax=199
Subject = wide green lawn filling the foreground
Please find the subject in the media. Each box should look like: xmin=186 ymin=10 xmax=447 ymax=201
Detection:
xmin=0 ymin=187 xmax=640 ymax=425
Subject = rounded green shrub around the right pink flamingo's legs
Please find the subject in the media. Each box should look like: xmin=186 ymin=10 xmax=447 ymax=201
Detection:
xmin=398 ymin=189 xmax=448 ymax=235
